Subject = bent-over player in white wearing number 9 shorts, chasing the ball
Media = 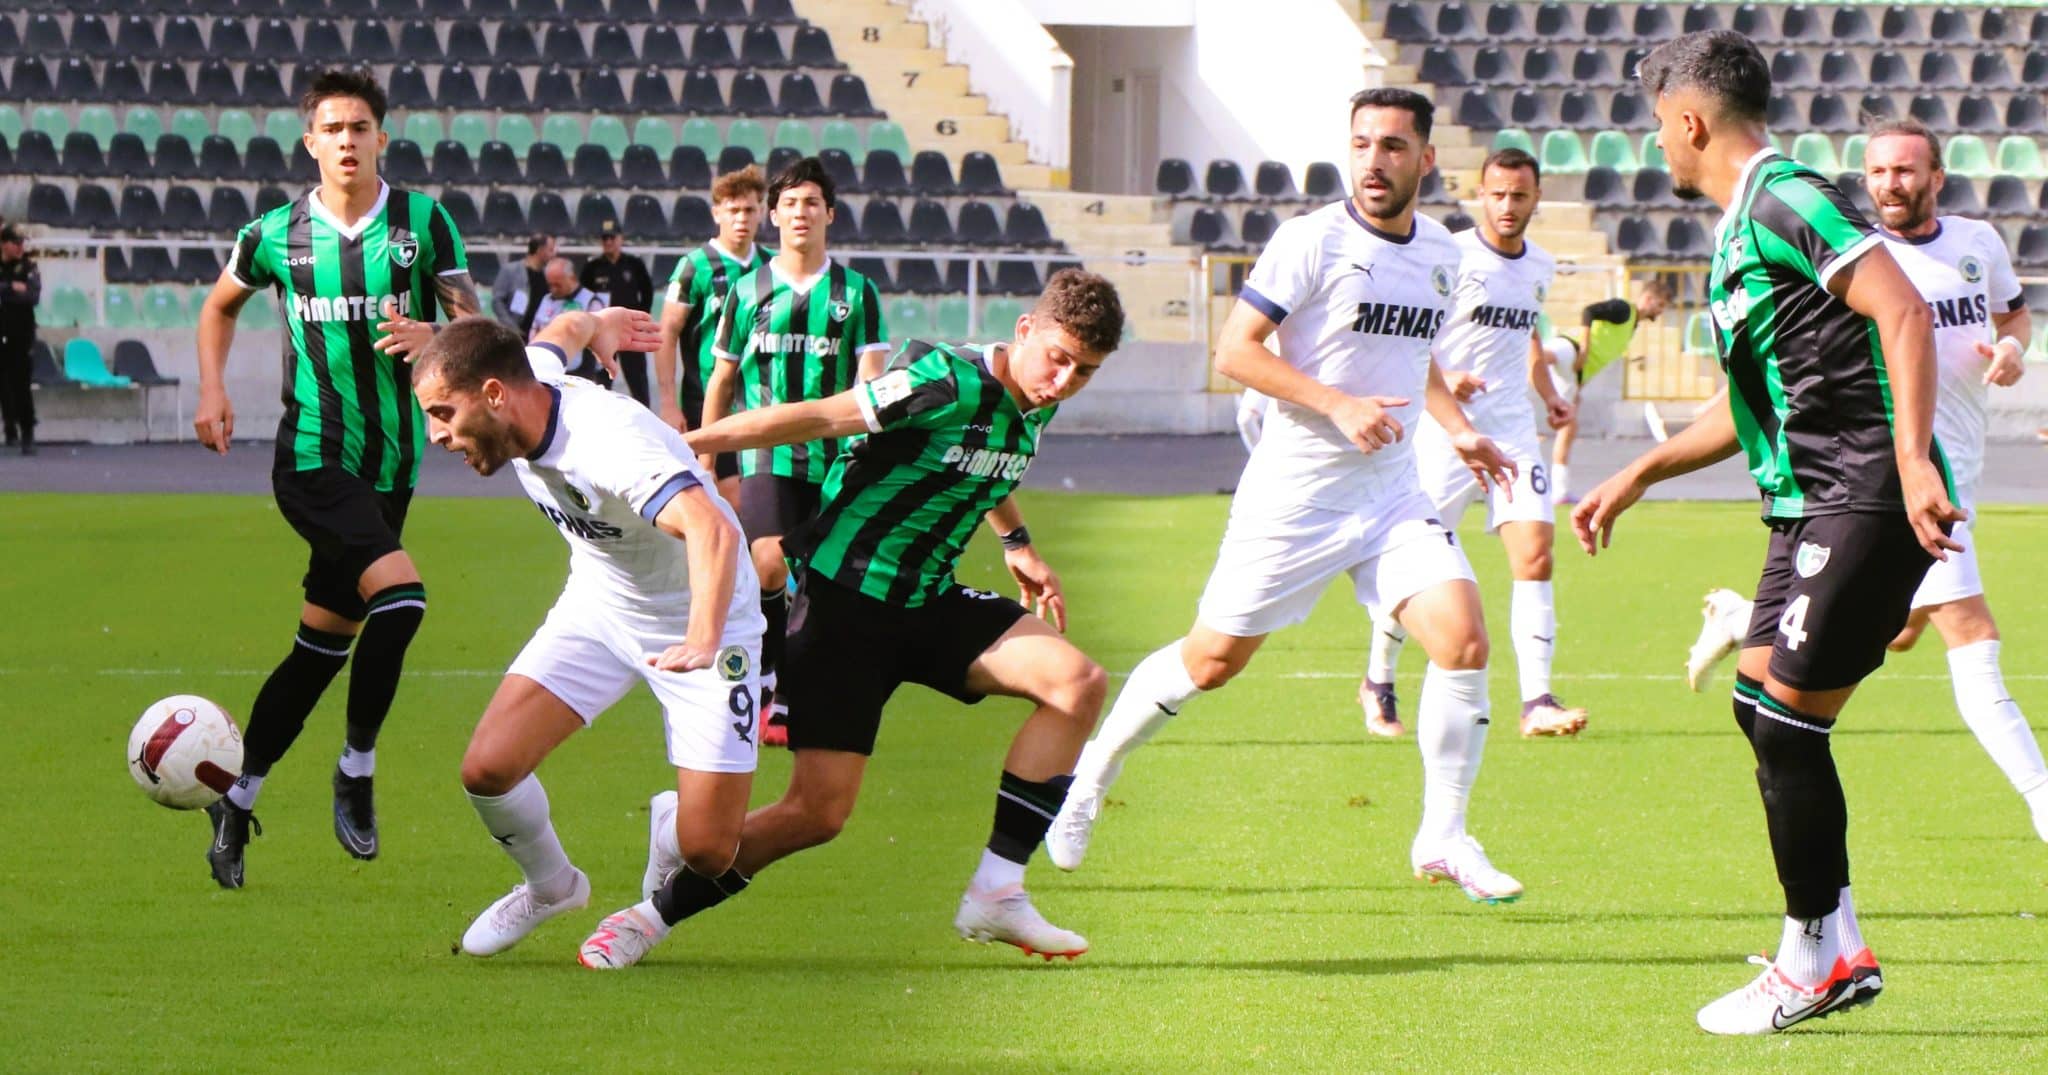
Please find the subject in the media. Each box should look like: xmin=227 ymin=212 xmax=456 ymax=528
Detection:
xmin=414 ymin=309 xmax=764 ymax=956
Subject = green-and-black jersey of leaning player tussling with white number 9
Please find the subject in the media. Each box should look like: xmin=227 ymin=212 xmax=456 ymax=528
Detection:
xmin=782 ymin=340 xmax=1057 ymax=608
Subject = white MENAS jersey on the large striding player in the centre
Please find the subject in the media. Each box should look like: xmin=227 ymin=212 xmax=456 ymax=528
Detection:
xmin=1237 ymin=201 xmax=1458 ymax=512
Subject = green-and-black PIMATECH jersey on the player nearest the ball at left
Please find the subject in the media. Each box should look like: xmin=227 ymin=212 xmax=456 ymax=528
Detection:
xmin=227 ymin=186 xmax=469 ymax=491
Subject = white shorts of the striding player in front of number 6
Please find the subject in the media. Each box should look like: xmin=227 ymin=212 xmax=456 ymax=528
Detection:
xmin=1196 ymin=491 xmax=1473 ymax=639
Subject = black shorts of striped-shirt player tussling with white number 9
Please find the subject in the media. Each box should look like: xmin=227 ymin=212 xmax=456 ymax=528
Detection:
xmin=776 ymin=571 xmax=1030 ymax=754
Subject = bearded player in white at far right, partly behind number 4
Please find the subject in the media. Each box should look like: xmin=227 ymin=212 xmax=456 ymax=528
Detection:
xmin=1686 ymin=121 xmax=2048 ymax=840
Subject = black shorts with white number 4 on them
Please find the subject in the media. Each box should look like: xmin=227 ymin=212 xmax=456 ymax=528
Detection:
xmin=1743 ymin=512 xmax=1933 ymax=690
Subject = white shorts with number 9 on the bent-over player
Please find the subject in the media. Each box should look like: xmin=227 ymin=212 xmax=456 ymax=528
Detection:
xmin=506 ymin=596 xmax=762 ymax=772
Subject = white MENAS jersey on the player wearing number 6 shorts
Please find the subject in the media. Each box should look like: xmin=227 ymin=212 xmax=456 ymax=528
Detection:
xmin=1432 ymin=227 xmax=1556 ymax=436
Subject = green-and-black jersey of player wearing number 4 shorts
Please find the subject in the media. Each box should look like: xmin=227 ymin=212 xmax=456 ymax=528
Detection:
xmin=1708 ymin=149 xmax=1954 ymax=518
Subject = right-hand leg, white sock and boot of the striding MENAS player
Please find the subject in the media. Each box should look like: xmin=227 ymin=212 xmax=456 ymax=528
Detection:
xmin=1395 ymin=579 xmax=1522 ymax=903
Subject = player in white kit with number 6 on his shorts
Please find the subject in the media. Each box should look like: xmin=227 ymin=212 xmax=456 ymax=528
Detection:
xmin=1358 ymin=149 xmax=1585 ymax=735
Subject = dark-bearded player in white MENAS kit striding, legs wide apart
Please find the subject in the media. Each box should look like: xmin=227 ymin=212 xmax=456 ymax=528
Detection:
xmin=1047 ymin=88 xmax=1522 ymax=903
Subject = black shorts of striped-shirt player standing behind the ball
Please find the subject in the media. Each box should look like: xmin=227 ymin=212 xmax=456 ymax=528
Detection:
xmin=270 ymin=467 xmax=412 ymax=620
